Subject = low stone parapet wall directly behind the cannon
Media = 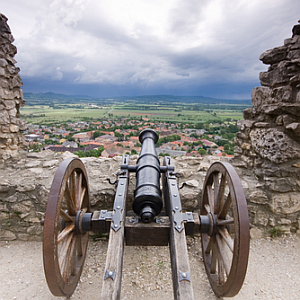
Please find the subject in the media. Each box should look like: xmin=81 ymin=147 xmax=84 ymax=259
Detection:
xmin=0 ymin=150 xmax=254 ymax=240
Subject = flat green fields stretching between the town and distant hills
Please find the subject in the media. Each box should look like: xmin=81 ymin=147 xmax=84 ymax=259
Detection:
xmin=20 ymin=103 xmax=245 ymax=124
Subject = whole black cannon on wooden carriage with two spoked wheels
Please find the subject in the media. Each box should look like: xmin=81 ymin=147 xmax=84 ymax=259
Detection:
xmin=43 ymin=129 xmax=250 ymax=300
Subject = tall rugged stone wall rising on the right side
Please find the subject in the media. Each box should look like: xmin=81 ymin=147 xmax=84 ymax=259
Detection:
xmin=234 ymin=25 xmax=300 ymax=236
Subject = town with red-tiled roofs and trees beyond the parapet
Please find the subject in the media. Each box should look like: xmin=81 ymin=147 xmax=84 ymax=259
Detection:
xmin=24 ymin=116 xmax=238 ymax=157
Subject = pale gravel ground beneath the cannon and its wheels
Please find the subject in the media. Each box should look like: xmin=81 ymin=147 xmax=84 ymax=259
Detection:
xmin=0 ymin=235 xmax=300 ymax=300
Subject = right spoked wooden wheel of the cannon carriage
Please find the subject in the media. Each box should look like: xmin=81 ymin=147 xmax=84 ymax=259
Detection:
xmin=200 ymin=162 xmax=250 ymax=297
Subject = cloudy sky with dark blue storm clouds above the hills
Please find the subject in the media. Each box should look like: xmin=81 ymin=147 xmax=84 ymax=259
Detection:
xmin=0 ymin=0 xmax=300 ymax=99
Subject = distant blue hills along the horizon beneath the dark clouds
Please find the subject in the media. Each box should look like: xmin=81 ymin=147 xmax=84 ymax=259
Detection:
xmin=24 ymin=92 xmax=251 ymax=105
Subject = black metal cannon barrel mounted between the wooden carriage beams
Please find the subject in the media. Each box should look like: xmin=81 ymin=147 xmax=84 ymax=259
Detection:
xmin=132 ymin=129 xmax=163 ymax=223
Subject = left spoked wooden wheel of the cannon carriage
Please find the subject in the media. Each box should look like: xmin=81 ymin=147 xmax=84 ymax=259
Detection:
xmin=43 ymin=158 xmax=90 ymax=296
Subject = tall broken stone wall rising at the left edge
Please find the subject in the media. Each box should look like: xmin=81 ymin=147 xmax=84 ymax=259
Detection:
xmin=0 ymin=14 xmax=27 ymax=159
